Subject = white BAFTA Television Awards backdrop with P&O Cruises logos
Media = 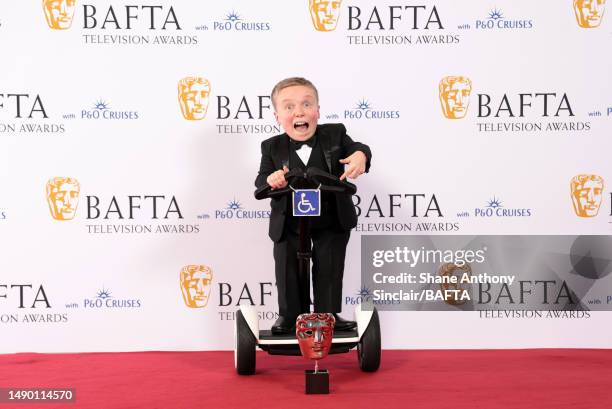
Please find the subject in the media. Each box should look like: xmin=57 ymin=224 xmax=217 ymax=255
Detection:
xmin=0 ymin=0 xmax=612 ymax=353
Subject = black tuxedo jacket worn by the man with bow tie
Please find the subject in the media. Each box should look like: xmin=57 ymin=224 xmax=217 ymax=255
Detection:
xmin=255 ymin=124 xmax=372 ymax=242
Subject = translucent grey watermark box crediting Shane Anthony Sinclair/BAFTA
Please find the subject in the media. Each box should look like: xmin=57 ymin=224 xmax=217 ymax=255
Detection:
xmin=361 ymin=235 xmax=612 ymax=311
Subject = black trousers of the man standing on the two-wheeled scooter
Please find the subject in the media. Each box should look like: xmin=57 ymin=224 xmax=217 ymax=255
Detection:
xmin=274 ymin=223 xmax=351 ymax=317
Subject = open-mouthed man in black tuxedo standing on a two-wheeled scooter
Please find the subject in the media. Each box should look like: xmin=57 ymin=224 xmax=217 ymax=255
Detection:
xmin=255 ymin=77 xmax=372 ymax=334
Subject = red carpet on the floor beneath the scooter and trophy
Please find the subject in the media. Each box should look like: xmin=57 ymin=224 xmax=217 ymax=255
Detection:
xmin=0 ymin=349 xmax=612 ymax=409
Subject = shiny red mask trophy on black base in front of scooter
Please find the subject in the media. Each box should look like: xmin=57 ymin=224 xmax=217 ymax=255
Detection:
xmin=295 ymin=313 xmax=336 ymax=395
